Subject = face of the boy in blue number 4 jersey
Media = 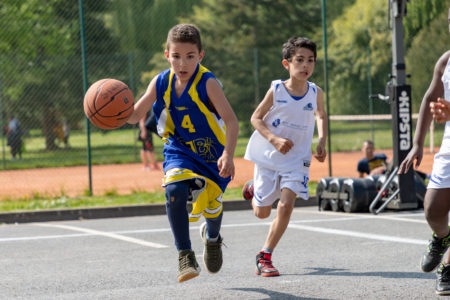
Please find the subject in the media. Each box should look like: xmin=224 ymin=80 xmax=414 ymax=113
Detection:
xmin=164 ymin=43 xmax=204 ymax=82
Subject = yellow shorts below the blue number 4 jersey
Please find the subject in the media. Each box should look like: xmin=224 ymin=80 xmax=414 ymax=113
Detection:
xmin=163 ymin=168 xmax=223 ymax=222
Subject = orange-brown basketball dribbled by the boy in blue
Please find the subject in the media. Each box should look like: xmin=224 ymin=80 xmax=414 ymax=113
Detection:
xmin=84 ymin=78 xmax=134 ymax=129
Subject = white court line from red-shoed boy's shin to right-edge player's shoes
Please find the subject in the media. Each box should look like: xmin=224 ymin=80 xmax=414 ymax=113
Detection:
xmin=289 ymin=224 xmax=428 ymax=245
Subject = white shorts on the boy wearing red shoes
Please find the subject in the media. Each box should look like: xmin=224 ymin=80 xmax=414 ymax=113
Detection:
xmin=253 ymin=164 xmax=309 ymax=206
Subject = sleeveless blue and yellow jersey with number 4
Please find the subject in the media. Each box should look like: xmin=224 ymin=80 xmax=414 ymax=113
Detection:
xmin=153 ymin=64 xmax=230 ymax=191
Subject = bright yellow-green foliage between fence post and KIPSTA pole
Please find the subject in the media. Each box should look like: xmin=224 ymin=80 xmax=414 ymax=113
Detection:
xmin=328 ymin=0 xmax=391 ymax=114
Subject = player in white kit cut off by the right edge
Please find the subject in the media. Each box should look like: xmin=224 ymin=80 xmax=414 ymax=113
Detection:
xmin=398 ymin=9 xmax=450 ymax=295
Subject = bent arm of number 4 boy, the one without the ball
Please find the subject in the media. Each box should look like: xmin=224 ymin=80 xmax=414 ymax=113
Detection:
xmin=206 ymin=79 xmax=239 ymax=178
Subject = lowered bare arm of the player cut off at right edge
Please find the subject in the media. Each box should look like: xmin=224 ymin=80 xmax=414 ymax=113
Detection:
xmin=398 ymin=51 xmax=450 ymax=174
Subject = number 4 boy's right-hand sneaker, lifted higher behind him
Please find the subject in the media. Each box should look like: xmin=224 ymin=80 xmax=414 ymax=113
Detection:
xmin=200 ymin=223 xmax=223 ymax=274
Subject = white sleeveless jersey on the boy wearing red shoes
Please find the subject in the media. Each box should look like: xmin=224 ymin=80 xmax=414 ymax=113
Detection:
xmin=244 ymin=80 xmax=317 ymax=171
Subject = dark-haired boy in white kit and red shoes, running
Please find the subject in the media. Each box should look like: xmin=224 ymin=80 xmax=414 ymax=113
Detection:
xmin=245 ymin=37 xmax=328 ymax=277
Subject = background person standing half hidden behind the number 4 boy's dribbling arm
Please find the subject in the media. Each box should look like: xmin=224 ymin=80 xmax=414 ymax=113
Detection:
xmin=138 ymin=111 xmax=159 ymax=170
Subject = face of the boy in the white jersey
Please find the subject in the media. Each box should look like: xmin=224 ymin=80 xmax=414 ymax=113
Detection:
xmin=282 ymin=48 xmax=316 ymax=80
